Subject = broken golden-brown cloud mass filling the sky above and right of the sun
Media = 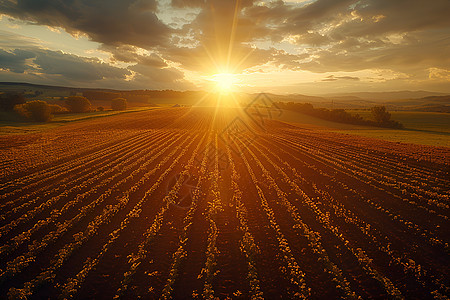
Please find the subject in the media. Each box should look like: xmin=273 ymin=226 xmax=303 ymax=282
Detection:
xmin=166 ymin=0 xmax=450 ymax=78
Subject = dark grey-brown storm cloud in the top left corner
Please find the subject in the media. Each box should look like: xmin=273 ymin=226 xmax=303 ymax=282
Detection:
xmin=0 ymin=0 xmax=171 ymax=48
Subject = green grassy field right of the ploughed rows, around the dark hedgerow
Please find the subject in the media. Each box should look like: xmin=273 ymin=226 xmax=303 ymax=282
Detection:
xmin=276 ymin=110 xmax=450 ymax=147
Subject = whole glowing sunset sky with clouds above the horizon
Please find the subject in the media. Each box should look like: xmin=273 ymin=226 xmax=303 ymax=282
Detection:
xmin=0 ymin=0 xmax=450 ymax=95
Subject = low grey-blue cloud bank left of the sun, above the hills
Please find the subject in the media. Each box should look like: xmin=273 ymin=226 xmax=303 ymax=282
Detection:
xmin=0 ymin=42 xmax=195 ymax=89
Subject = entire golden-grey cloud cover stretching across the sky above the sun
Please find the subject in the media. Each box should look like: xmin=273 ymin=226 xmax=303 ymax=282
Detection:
xmin=0 ymin=0 xmax=450 ymax=88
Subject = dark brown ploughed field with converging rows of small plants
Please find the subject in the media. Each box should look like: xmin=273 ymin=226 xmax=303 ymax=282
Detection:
xmin=0 ymin=107 xmax=450 ymax=299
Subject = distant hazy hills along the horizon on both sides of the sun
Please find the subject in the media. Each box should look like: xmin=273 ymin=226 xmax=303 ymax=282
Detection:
xmin=0 ymin=82 xmax=450 ymax=112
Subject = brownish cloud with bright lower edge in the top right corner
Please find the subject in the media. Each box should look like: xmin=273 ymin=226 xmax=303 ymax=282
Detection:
xmin=248 ymin=0 xmax=450 ymax=41
